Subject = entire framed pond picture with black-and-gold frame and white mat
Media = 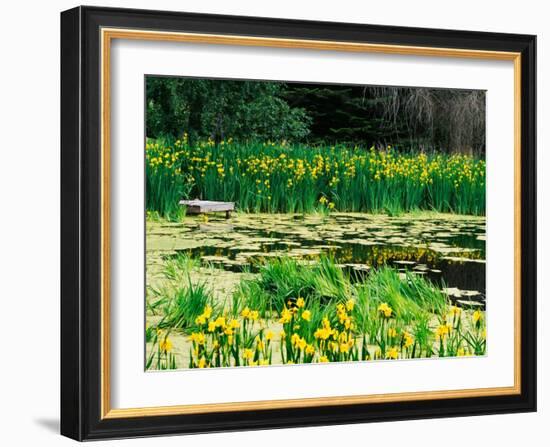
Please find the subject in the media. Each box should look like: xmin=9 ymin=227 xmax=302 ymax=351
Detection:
xmin=61 ymin=7 xmax=536 ymax=440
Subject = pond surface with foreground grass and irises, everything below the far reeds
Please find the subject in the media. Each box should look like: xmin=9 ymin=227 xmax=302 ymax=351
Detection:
xmin=147 ymin=213 xmax=485 ymax=368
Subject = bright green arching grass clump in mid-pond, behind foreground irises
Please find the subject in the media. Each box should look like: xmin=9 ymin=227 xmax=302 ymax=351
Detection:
xmin=233 ymin=257 xmax=448 ymax=326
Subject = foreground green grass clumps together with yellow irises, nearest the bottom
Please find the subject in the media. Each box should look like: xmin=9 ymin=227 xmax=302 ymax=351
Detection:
xmin=146 ymin=257 xmax=486 ymax=369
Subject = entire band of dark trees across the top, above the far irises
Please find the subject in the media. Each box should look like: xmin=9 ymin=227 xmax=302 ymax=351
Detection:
xmin=146 ymin=77 xmax=485 ymax=154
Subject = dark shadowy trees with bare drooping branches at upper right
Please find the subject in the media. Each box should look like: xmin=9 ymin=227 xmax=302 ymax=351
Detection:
xmin=285 ymin=83 xmax=485 ymax=153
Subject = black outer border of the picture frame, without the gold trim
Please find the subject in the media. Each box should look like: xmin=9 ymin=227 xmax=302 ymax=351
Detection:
xmin=60 ymin=6 xmax=537 ymax=440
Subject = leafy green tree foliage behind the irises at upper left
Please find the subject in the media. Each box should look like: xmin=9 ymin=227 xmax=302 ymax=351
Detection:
xmin=146 ymin=77 xmax=310 ymax=142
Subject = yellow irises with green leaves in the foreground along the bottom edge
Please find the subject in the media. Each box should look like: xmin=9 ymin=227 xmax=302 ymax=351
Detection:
xmin=148 ymin=297 xmax=486 ymax=369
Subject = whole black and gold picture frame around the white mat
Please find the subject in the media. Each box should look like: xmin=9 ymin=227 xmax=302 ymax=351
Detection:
xmin=61 ymin=6 xmax=537 ymax=441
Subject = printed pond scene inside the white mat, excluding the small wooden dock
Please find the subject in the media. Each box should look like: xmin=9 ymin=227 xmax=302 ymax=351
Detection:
xmin=145 ymin=78 xmax=486 ymax=370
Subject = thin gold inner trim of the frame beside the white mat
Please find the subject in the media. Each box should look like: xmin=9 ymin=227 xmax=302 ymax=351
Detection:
xmin=100 ymin=28 xmax=521 ymax=419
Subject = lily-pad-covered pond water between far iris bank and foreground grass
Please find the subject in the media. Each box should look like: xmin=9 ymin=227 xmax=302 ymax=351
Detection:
xmin=147 ymin=213 xmax=485 ymax=306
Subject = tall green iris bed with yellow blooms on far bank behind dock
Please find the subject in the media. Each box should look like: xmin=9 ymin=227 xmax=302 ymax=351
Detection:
xmin=146 ymin=140 xmax=485 ymax=219
